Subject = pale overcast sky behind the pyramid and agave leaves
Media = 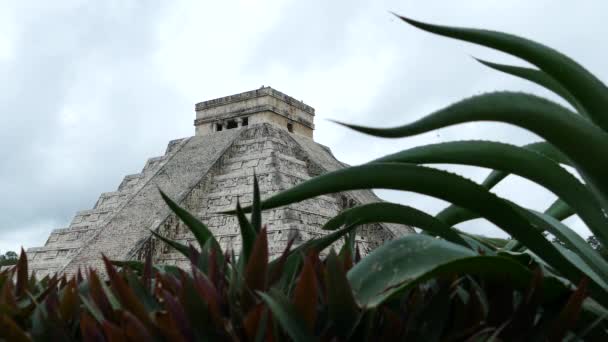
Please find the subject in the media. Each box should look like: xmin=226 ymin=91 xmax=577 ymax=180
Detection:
xmin=0 ymin=0 xmax=608 ymax=252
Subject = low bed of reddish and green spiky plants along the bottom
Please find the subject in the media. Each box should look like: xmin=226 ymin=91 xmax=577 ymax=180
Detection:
xmin=0 ymin=181 xmax=597 ymax=341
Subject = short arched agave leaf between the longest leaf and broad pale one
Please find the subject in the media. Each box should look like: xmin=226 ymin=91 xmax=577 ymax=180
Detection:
xmin=322 ymin=203 xmax=469 ymax=247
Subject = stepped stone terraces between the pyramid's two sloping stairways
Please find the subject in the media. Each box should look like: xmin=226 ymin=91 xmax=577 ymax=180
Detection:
xmin=151 ymin=125 xmax=371 ymax=268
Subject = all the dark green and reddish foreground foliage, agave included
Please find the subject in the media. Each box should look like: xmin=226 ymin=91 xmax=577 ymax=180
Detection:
xmin=0 ymin=14 xmax=608 ymax=341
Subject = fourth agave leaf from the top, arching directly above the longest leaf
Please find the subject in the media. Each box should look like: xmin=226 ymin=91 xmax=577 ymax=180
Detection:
xmin=374 ymin=141 xmax=608 ymax=245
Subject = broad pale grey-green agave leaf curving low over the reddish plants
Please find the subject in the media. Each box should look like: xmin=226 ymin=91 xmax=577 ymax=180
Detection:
xmin=348 ymin=234 xmax=567 ymax=308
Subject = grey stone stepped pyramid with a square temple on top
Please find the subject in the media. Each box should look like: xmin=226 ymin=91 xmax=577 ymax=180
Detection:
xmin=27 ymin=87 xmax=414 ymax=276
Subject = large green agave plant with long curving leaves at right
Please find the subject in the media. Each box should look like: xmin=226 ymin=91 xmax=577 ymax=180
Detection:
xmin=243 ymin=17 xmax=608 ymax=340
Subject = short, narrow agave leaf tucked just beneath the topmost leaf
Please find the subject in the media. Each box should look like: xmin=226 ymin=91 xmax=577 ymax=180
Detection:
xmin=475 ymin=58 xmax=589 ymax=117
